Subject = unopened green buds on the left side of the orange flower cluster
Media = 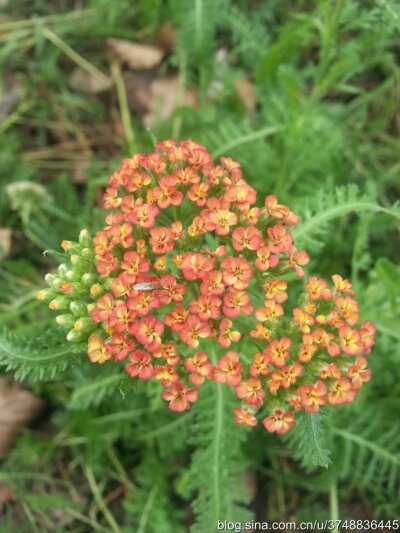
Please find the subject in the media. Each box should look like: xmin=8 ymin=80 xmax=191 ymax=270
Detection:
xmin=36 ymin=229 xmax=107 ymax=342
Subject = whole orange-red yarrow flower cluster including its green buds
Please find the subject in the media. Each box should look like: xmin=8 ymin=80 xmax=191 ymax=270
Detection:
xmin=38 ymin=140 xmax=375 ymax=434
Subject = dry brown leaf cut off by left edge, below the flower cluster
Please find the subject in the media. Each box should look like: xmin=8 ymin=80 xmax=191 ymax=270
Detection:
xmin=0 ymin=379 xmax=44 ymax=458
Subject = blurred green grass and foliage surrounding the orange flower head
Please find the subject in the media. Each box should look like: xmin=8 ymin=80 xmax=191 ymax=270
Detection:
xmin=0 ymin=0 xmax=400 ymax=533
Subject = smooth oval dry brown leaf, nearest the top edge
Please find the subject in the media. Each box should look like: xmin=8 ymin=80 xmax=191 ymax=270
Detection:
xmin=107 ymin=39 xmax=164 ymax=70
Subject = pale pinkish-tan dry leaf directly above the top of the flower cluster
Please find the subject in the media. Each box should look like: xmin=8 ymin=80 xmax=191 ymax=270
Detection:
xmin=142 ymin=75 xmax=198 ymax=128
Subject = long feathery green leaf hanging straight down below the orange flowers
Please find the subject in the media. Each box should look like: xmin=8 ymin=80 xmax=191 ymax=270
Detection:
xmin=190 ymin=383 xmax=252 ymax=533
